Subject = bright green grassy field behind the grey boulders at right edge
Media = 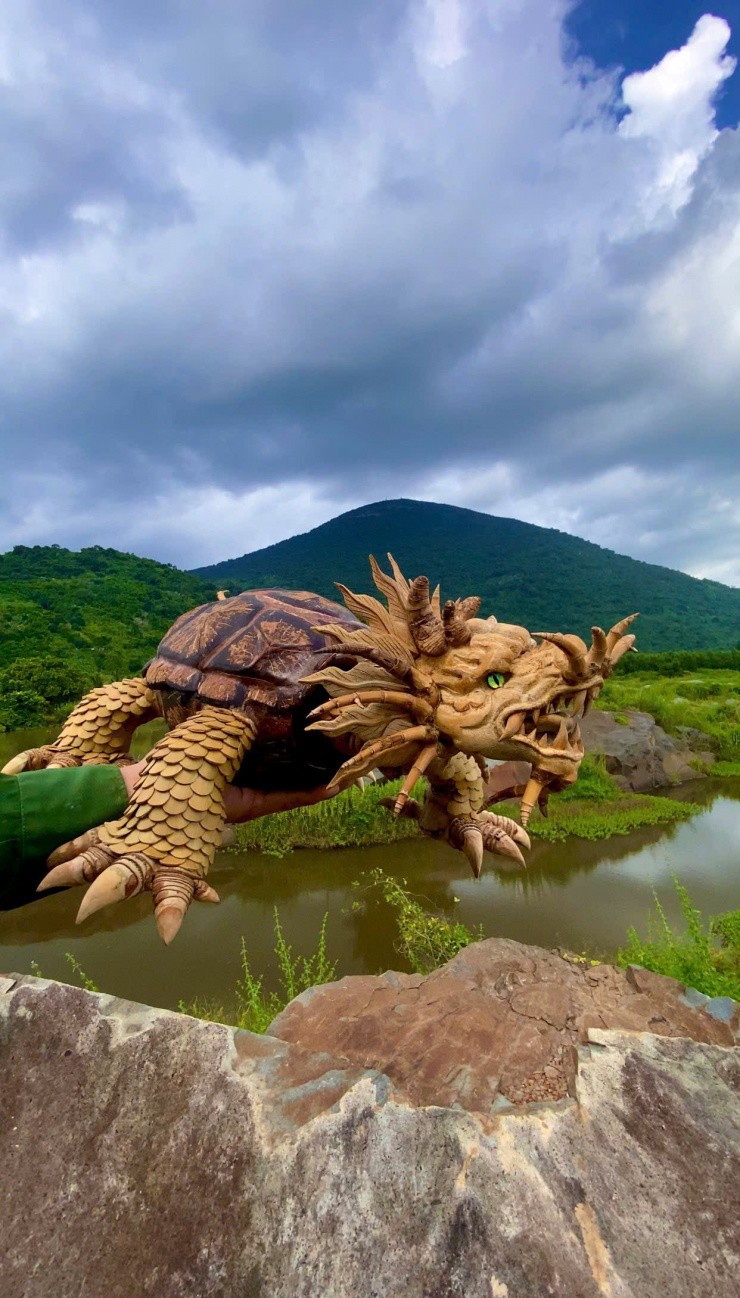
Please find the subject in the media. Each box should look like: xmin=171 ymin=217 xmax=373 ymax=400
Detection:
xmin=597 ymin=659 xmax=740 ymax=758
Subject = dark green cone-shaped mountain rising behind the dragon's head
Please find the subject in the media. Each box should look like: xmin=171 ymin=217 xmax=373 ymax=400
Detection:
xmin=197 ymin=500 xmax=740 ymax=652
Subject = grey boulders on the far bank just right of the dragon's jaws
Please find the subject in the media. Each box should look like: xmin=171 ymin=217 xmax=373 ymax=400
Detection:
xmin=580 ymin=709 xmax=714 ymax=793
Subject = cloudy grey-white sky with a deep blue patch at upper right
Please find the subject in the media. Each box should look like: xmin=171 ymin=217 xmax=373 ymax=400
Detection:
xmin=0 ymin=0 xmax=740 ymax=585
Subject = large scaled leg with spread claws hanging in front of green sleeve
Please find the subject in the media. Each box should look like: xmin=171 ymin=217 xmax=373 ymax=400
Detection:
xmin=39 ymin=706 xmax=256 ymax=945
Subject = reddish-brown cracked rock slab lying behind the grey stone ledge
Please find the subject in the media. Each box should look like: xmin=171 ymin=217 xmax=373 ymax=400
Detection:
xmin=270 ymin=938 xmax=734 ymax=1112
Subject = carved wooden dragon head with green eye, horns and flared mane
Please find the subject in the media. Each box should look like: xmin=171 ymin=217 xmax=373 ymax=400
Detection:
xmin=309 ymin=556 xmax=636 ymax=867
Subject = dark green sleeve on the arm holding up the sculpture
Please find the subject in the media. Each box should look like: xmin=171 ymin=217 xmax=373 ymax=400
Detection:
xmin=0 ymin=766 xmax=129 ymax=909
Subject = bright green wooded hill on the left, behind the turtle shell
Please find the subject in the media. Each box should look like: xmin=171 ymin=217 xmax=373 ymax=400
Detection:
xmin=0 ymin=545 xmax=213 ymax=729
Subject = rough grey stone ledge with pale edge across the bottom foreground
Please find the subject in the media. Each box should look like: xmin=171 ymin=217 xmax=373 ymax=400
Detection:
xmin=0 ymin=944 xmax=740 ymax=1298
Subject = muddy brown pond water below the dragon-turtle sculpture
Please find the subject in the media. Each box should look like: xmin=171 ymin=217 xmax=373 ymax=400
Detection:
xmin=0 ymin=731 xmax=740 ymax=1009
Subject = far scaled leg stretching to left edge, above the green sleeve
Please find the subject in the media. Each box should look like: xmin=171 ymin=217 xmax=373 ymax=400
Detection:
xmin=3 ymin=676 xmax=160 ymax=775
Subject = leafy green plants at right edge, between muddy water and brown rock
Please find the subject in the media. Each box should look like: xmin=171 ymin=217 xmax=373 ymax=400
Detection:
xmin=615 ymin=879 xmax=740 ymax=1001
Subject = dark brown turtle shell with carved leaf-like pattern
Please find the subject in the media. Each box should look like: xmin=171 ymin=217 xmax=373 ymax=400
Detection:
xmin=144 ymin=589 xmax=360 ymax=710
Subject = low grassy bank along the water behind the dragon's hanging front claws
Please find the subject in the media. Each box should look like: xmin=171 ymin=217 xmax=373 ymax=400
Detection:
xmin=232 ymin=757 xmax=700 ymax=857
